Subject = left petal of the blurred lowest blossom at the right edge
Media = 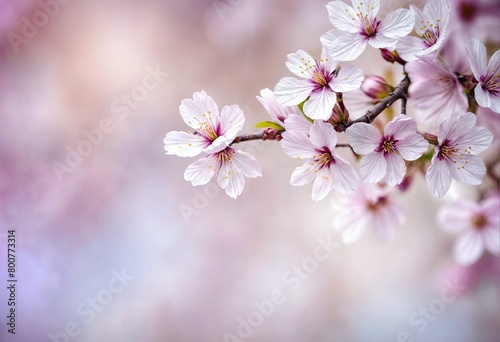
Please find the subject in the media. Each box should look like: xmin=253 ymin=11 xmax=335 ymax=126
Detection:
xmin=437 ymin=201 xmax=477 ymax=233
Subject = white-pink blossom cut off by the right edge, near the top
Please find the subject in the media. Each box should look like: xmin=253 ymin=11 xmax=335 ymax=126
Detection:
xmin=466 ymin=39 xmax=500 ymax=113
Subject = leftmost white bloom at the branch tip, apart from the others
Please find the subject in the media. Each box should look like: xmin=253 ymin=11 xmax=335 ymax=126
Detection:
xmin=163 ymin=91 xmax=262 ymax=198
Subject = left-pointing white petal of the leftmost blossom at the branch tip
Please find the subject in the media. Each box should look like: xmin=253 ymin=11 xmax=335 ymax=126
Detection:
xmin=163 ymin=131 xmax=210 ymax=157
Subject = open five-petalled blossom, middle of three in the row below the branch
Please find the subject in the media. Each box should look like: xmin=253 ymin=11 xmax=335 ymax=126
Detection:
xmin=346 ymin=115 xmax=429 ymax=186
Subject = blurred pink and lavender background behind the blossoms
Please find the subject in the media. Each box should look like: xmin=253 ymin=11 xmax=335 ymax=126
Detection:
xmin=0 ymin=0 xmax=500 ymax=342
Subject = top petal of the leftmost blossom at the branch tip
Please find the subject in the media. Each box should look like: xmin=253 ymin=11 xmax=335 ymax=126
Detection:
xmin=179 ymin=91 xmax=219 ymax=131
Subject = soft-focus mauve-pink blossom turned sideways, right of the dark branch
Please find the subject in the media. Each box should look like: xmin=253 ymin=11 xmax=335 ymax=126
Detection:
xmin=405 ymin=56 xmax=468 ymax=128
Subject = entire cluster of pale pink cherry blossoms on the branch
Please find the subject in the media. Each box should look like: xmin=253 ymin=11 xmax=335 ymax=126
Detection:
xmin=163 ymin=0 xmax=500 ymax=264
